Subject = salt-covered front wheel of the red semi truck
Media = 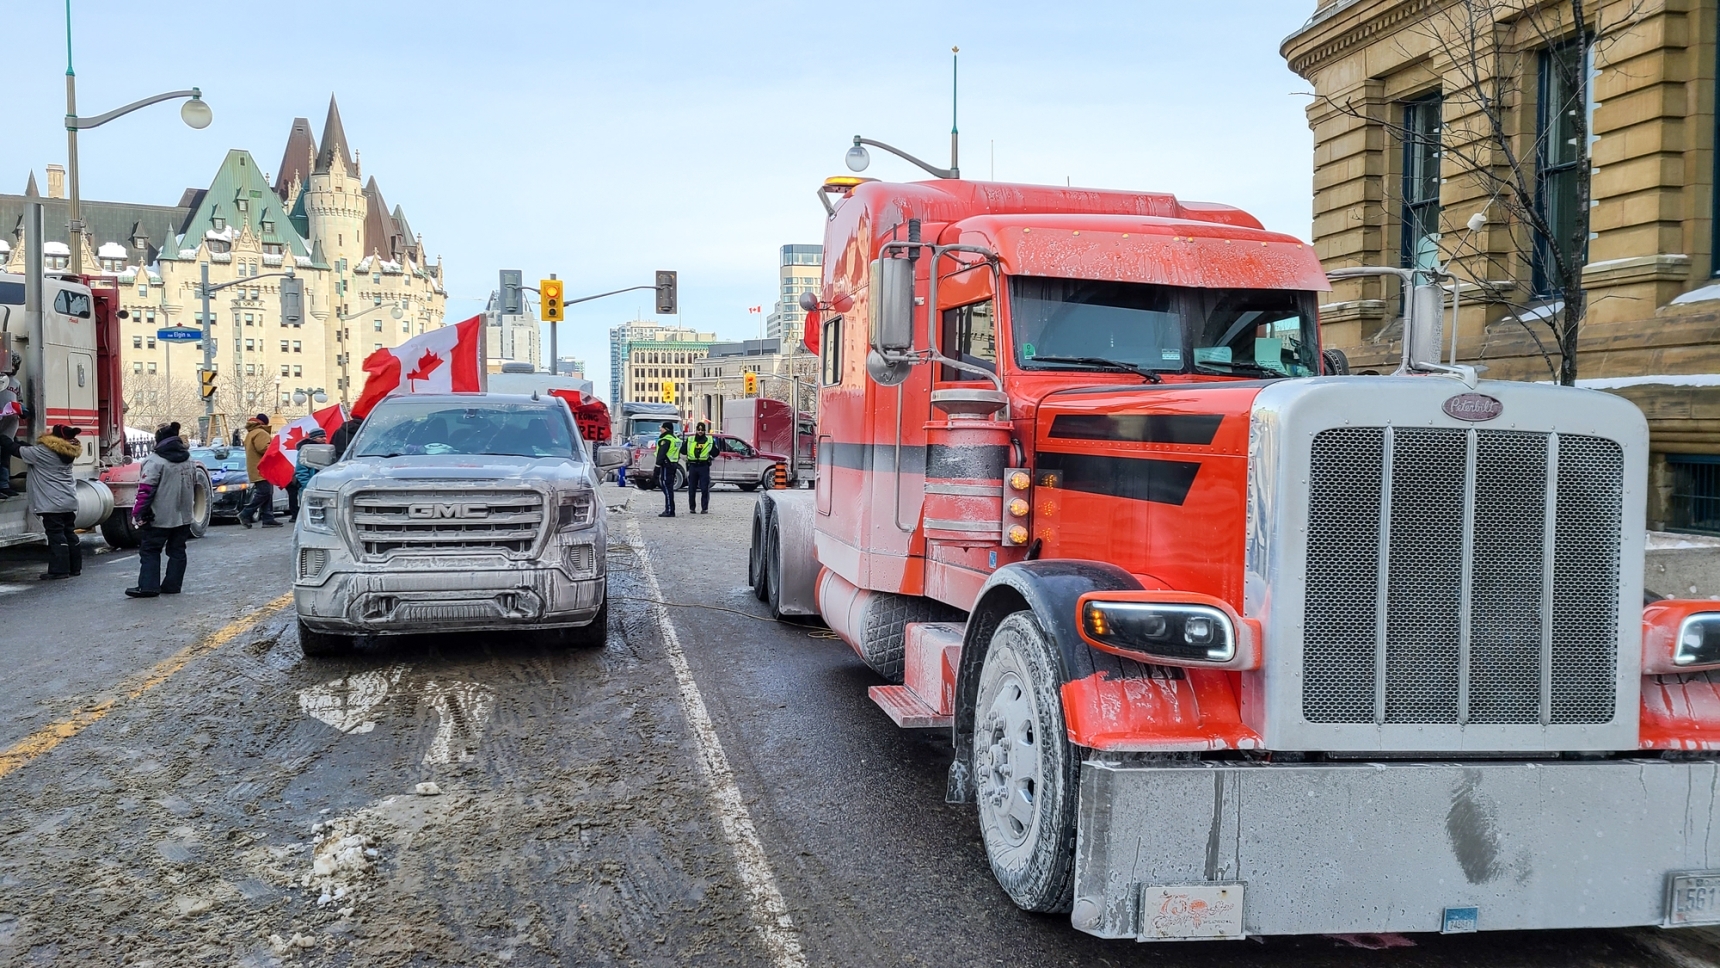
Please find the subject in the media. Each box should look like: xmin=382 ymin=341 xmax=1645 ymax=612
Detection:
xmin=974 ymin=612 xmax=1080 ymax=913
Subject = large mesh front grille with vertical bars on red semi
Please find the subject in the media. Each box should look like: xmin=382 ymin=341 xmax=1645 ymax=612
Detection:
xmin=1302 ymin=426 xmax=1624 ymax=726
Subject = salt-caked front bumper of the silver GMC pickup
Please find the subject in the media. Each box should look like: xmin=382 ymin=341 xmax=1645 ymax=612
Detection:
xmin=292 ymin=535 xmax=605 ymax=634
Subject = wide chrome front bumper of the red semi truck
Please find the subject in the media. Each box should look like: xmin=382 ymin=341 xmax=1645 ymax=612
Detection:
xmin=1072 ymin=760 xmax=1720 ymax=940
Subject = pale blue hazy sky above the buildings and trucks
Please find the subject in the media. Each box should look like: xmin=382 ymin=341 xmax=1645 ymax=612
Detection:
xmin=0 ymin=0 xmax=1314 ymax=402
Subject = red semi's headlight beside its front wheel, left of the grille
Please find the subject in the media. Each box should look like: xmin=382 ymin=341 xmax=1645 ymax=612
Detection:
xmin=1075 ymin=591 xmax=1261 ymax=669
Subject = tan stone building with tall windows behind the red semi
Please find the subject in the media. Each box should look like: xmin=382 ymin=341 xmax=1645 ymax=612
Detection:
xmin=1281 ymin=0 xmax=1720 ymax=531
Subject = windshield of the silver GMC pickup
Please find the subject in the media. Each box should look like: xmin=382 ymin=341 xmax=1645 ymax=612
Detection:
xmin=349 ymin=401 xmax=581 ymax=459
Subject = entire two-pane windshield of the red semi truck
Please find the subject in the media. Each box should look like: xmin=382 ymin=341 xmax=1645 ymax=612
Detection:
xmin=1010 ymin=275 xmax=1319 ymax=377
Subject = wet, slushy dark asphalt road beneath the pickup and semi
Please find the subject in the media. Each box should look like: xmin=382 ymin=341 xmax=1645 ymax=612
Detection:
xmin=0 ymin=488 xmax=1720 ymax=968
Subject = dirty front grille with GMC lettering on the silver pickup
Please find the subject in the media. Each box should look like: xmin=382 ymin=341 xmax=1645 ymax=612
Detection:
xmin=353 ymin=490 xmax=544 ymax=555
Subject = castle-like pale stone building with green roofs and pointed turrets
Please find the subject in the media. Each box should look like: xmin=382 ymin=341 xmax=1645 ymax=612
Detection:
xmin=0 ymin=98 xmax=445 ymax=426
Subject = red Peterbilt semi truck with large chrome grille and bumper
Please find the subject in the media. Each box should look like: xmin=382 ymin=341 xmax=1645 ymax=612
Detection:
xmin=750 ymin=179 xmax=1720 ymax=940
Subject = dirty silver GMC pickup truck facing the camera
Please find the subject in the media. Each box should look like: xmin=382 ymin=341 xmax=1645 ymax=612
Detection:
xmin=292 ymin=394 xmax=624 ymax=657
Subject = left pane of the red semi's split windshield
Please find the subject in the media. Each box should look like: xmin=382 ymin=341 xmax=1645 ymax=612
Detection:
xmin=1010 ymin=275 xmax=1183 ymax=371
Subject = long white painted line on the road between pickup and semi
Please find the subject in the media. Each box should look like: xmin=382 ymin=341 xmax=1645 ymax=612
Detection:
xmin=628 ymin=521 xmax=807 ymax=968
